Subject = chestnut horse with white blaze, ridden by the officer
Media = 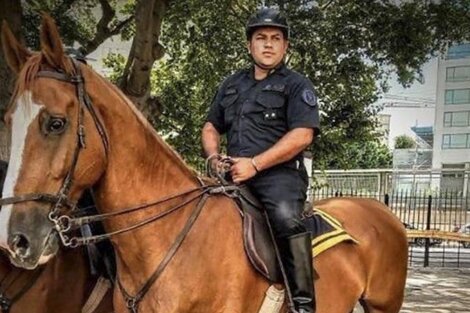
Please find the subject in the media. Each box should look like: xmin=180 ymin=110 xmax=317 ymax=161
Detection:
xmin=0 ymin=17 xmax=407 ymax=313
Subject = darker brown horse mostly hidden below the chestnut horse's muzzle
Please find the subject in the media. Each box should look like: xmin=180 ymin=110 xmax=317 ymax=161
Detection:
xmin=0 ymin=160 xmax=113 ymax=313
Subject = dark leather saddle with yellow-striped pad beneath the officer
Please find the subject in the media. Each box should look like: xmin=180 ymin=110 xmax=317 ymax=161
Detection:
xmin=226 ymin=186 xmax=359 ymax=283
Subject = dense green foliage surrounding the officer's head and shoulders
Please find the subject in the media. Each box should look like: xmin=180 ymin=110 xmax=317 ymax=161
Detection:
xmin=141 ymin=0 xmax=470 ymax=168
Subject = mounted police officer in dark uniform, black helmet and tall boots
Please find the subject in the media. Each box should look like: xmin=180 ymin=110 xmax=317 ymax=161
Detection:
xmin=202 ymin=8 xmax=319 ymax=313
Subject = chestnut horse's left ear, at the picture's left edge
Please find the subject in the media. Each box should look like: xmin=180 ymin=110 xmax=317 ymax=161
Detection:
xmin=2 ymin=21 xmax=31 ymax=73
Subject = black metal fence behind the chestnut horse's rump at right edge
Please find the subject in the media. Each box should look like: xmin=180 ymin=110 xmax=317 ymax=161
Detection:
xmin=309 ymin=188 xmax=470 ymax=268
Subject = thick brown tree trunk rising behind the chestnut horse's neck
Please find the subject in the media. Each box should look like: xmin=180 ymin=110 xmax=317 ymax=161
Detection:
xmin=119 ymin=0 xmax=168 ymax=117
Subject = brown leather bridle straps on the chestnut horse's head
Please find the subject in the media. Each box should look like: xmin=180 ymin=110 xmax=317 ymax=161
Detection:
xmin=0 ymin=58 xmax=109 ymax=244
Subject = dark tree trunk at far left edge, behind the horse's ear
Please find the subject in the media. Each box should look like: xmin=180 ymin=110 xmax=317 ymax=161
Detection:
xmin=0 ymin=0 xmax=22 ymax=160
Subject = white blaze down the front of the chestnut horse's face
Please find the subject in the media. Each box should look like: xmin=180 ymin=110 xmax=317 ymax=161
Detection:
xmin=0 ymin=91 xmax=42 ymax=249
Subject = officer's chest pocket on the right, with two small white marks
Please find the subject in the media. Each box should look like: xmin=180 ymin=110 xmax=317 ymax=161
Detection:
xmin=253 ymin=91 xmax=286 ymax=126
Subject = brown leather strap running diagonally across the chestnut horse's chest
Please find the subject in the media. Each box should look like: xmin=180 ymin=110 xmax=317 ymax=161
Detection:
xmin=117 ymin=193 xmax=209 ymax=313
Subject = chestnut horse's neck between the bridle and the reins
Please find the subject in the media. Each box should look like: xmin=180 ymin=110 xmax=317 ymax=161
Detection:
xmin=88 ymin=72 xmax=197 ymax=208
